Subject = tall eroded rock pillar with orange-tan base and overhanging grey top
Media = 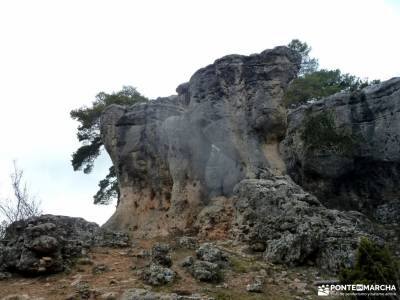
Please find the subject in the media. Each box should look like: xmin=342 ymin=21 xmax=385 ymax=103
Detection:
xmin=101 ymin=47 xmax=300 ymax=236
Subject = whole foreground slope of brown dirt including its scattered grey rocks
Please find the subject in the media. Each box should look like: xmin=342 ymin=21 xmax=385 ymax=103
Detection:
xmin=0 ymin=238 xmax=340 ymax=300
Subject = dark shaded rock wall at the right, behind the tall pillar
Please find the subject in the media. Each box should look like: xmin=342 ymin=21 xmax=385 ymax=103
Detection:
xmin=281 ymin=78 xmax=400 ymax=215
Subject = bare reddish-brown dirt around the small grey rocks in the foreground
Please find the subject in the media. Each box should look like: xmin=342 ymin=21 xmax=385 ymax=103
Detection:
xmin=0 ymin=240 xmax=334 ymax=300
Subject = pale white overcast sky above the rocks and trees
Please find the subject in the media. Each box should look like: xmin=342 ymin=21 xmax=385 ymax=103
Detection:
xmin=0 ymin=0 xmax=400 ymax=223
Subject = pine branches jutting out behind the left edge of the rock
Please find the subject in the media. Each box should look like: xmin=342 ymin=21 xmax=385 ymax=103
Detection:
xmin=71 ymin=86 xmax=148 ymax=204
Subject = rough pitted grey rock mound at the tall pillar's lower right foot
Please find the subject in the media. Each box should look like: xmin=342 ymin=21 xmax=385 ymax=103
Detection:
xmin=233 ymin=177 xmax=381 ymax=272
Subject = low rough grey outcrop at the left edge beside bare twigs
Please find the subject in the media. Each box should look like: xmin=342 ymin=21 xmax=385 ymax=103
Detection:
xmin=0 ymin=215 xmax=127 ymax=275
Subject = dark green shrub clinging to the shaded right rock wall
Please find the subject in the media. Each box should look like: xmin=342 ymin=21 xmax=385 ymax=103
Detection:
xmin=301 ymin=111 xmax=357 ymax=155
